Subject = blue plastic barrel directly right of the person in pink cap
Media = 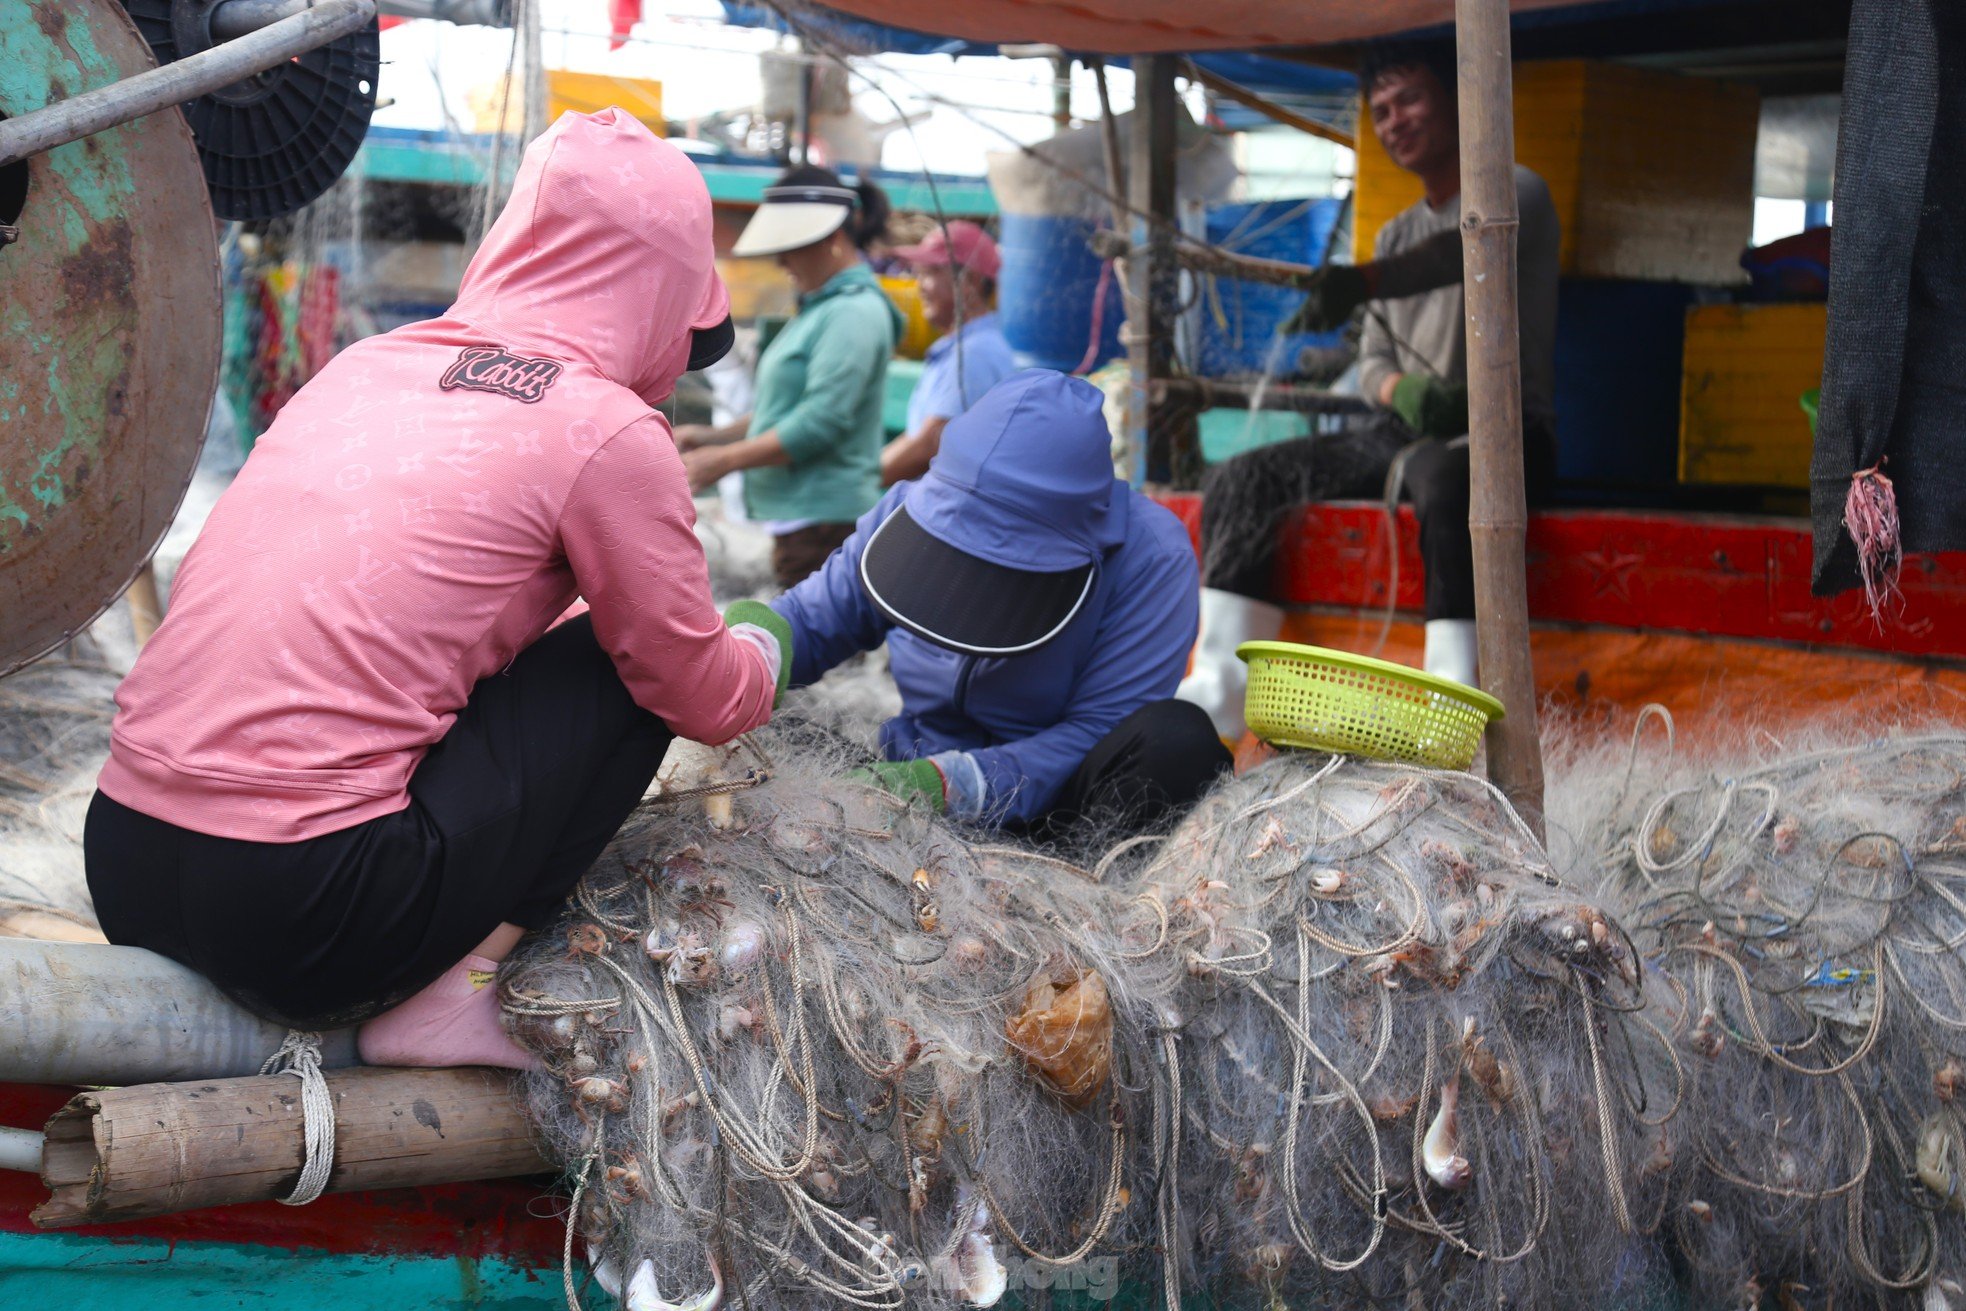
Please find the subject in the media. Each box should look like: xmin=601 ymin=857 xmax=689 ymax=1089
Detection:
xmin=997 ymin=212 xmax=1127 ymax=373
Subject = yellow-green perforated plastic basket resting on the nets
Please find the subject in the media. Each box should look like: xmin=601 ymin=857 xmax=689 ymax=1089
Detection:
xmin=1237 ymin=643 xmax=1502 ymax=769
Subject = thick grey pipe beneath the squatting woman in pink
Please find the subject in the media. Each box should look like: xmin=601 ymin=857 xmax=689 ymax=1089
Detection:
xmin=0 ymin=938 xmax=358 ymax=1085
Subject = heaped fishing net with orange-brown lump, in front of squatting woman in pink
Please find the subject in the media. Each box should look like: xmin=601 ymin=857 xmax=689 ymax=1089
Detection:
xmin=501 ymin=731 xmax=1152 ymax=1307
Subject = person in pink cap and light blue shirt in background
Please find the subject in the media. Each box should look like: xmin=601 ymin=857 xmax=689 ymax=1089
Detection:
xmin=881 ymin=218 xmax=1016 ymax=487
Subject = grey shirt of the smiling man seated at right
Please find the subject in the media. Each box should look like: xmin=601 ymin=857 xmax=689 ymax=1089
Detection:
xmin=1359 ymin=165 xmax=1563 ymax=425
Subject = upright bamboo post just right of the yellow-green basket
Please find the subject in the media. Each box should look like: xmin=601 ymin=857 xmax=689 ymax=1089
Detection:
xmin=1455 ymin=0 xmax=1543 ymax=835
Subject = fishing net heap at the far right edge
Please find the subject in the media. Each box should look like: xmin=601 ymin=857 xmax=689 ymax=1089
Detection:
xmin=1579 ymin=731 xmax=1966 ymax=1309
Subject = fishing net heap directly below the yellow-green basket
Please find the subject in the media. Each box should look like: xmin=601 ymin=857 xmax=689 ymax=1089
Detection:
xmin=1132 ymin=757 xmax=1683 ymax=1307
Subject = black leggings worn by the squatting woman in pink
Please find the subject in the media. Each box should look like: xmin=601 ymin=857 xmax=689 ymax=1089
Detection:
xmin=83 ymin=617 xmax=670 ymax=1028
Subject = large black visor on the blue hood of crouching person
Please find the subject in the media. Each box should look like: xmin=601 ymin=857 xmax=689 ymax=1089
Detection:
xmin=861 ymin=507 xmax=1097 ymax=656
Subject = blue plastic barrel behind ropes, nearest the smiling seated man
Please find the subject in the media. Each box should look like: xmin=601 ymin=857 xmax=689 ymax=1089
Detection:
xmin=1201 ymin=199 xmax=1345 ymax=377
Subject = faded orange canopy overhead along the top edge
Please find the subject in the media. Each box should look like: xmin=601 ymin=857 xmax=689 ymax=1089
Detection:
xmin=743 ymin=0 xmax=1604 ymax=55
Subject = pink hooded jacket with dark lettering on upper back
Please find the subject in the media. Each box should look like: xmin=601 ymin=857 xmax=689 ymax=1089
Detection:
xmin=100 ymin=110 xmax=775 ymax=841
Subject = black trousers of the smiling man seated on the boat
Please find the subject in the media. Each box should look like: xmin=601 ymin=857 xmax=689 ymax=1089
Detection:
xmin=1201 ymin=415 xmax=1557 ymax=619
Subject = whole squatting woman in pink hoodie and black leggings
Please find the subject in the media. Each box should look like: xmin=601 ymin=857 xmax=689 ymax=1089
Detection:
xmin=85 ymin=110 xmax=790 ymax=1065
